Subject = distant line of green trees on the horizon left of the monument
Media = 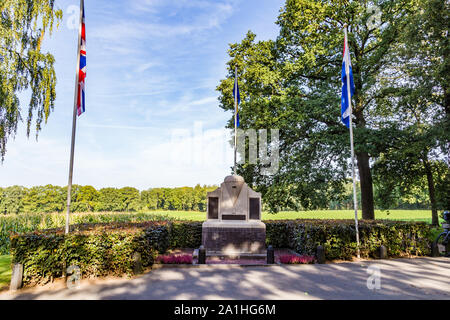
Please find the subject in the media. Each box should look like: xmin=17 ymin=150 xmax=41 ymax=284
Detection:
xmin=0 ymin=185 xmax=217 ymax=214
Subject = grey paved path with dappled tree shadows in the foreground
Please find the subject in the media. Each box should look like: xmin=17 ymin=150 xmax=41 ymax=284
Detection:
xmin=0 ymin=258 xmax=450 ymax=300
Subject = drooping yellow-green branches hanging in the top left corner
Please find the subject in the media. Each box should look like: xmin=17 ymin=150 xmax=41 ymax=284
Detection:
xmin=0 ymin=0 xmax=62 ymax=160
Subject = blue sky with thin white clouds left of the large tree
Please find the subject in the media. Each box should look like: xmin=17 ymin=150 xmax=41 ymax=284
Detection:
xmin=0 ymin=0 xmax=283 ymax=190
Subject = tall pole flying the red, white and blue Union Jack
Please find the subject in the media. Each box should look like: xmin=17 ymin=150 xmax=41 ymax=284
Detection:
xmin=66 ymin=0 xmax=84 ymax=234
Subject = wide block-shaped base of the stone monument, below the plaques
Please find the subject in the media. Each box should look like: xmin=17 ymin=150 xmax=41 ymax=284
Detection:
xmin=202 ymin=221 xmax=266 ymax=257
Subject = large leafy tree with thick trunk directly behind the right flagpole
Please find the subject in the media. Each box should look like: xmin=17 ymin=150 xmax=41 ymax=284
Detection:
xmin=218 ymin=0 xmax=424 ymax=219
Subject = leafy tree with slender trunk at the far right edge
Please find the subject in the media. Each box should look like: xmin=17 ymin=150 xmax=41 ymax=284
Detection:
xmin=375 ymin=0 xmax=450 ymax=225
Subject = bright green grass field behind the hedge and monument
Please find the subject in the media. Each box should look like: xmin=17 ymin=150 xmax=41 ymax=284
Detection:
xmin=145 ymin=210 xmax=440 ymax=223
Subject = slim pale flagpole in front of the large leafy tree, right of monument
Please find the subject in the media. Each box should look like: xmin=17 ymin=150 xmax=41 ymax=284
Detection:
xmin=344 ymin=24 xmax=361 ymax=259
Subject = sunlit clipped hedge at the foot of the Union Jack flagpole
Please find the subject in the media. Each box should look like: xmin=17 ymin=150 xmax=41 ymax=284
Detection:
xmin=11 ymin=222 xmax=169 ymax=285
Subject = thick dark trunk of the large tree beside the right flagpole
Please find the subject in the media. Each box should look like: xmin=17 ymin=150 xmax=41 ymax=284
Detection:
xmin=356 ymin=152 xmax=375 ymax=220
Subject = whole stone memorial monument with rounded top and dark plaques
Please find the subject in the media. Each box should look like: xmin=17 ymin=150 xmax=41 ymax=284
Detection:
xmin=202 ymin=175 xmax=266 ymax=257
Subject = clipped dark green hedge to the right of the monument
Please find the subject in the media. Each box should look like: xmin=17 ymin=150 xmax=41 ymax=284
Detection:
xmin=266 ymin=220 xmax=432 ymax=260
